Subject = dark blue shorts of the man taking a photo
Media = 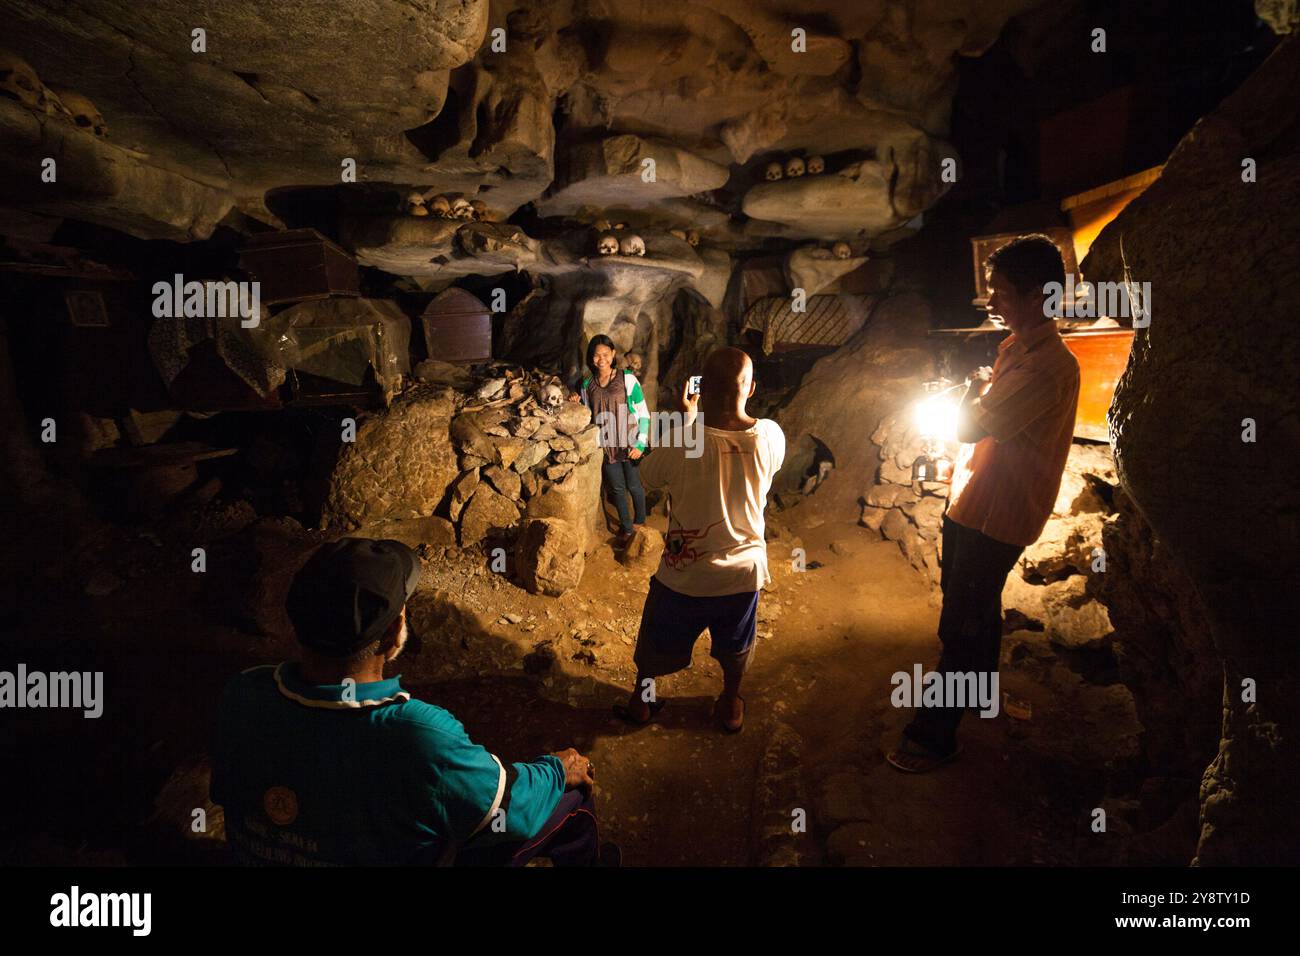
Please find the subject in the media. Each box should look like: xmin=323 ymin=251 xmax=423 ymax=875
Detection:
xmin=632 ymin=578 xmax=759 ymax=678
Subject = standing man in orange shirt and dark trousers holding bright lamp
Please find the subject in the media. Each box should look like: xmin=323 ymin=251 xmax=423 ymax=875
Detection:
xmin=887 ymin=235 xmax=1079 ymax=773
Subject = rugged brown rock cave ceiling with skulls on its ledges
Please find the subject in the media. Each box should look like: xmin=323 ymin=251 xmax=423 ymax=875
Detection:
xmin=0 ymin=0 xmax=1035 ymax=274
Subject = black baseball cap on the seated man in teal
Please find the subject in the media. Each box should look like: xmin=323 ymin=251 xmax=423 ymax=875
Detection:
xmin=285 ymin=537 xmax=420 ymax=657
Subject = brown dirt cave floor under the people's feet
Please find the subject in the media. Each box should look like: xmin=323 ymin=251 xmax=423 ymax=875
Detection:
xmin=0 ymin=489 xmax=1164 ymax=866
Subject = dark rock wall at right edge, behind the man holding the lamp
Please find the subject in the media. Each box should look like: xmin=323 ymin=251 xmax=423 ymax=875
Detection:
xmin=1082 ymin=36 xmax=1300 ymax=865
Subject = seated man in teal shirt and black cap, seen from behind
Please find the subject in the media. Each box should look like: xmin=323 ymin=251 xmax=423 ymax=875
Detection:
xmin=212 ymin=538 xmax=616 ymax=866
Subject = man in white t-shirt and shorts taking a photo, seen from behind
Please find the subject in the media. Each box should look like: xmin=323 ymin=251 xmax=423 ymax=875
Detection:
xmin=616 ymin=349 xmax=785 ymax=734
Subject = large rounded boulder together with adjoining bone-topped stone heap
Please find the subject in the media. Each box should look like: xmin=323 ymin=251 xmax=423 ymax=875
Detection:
xmin=322 ymin=362 xmax=602 ymax=594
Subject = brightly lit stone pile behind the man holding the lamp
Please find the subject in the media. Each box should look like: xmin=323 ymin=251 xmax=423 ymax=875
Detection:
xmin=858 ymin=400 xmax=1118 ymax=649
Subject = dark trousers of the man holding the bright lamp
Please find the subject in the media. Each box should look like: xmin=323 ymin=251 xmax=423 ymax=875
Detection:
xmin=904 ymin=515 xmax=1024 ymax=754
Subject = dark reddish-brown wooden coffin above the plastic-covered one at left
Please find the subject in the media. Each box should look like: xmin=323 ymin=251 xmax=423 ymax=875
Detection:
xmin=239 ymin=229 xmax=361 ymax=306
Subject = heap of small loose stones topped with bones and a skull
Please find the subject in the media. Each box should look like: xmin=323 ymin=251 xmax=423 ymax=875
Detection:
xmin=449 ymin=367 xmax=598 ymax=540
